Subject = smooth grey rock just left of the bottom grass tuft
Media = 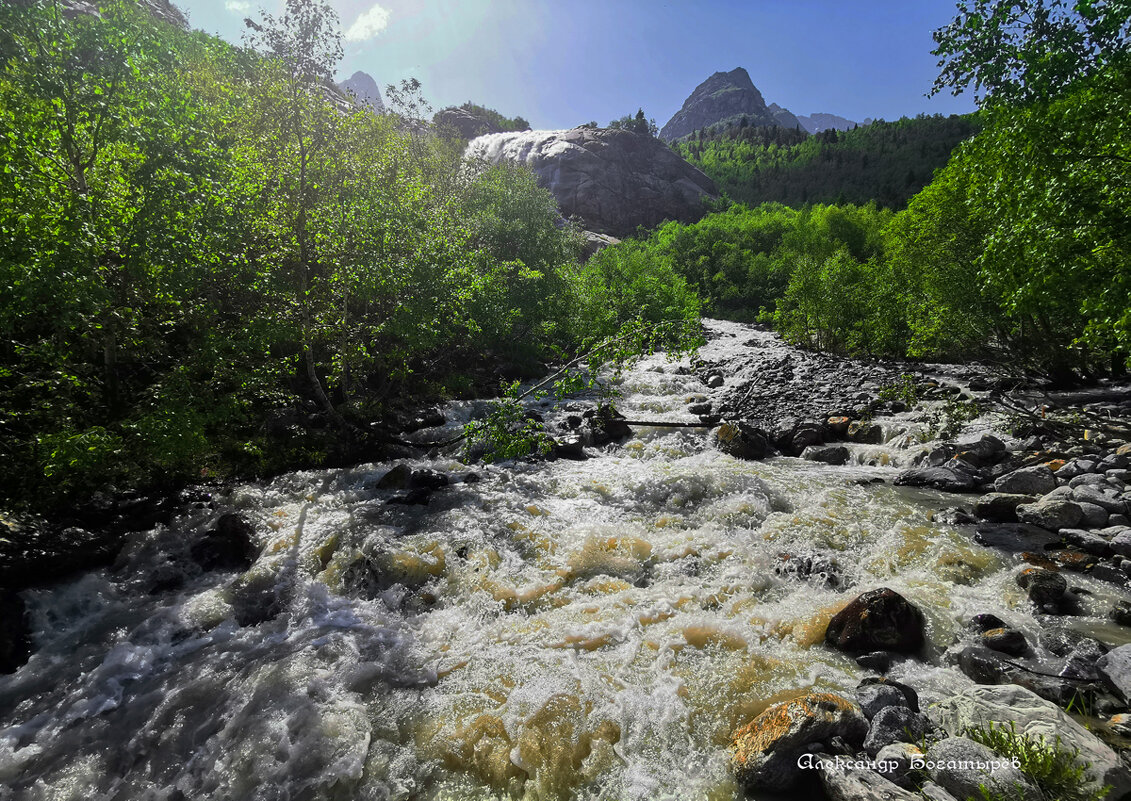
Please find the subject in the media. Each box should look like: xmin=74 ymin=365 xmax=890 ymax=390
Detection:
xmin=926 ymin=737 xmax=1045 ymax=801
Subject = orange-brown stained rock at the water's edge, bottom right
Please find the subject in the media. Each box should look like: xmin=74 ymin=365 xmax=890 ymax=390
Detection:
xmin=731 ymin=692 xmax=867 ymax=792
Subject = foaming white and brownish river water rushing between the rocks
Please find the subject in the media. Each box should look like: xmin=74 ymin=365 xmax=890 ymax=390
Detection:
xmin=0 ymin=321 xmax=1126 ymax=801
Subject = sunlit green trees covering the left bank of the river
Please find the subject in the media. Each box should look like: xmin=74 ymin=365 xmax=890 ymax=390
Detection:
xmin=0 ymin=0 xmax=698 ymax=508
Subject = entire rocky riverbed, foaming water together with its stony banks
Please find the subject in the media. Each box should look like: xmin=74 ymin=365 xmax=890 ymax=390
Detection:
xmin=0 ymin=321 xmax=1131 ymax=801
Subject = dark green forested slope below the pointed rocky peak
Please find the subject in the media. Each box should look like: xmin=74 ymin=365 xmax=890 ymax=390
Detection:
xmin=674 ymin=114 xmax=981 ymax=208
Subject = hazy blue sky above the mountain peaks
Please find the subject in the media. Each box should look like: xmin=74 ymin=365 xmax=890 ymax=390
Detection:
xmin=175 ymin=0 xmax=974 ymax=128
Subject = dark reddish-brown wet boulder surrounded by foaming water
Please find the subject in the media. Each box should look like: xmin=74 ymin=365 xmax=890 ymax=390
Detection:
xmin=824 ymin=587 xmax=923 ymax=653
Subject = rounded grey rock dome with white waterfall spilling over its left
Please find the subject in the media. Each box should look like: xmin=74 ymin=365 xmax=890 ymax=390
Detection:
xmin=466 ymin=128 xmax=717 ymax=236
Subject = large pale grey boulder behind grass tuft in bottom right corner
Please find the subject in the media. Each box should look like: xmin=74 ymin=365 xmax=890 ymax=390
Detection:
xmin=927 ymin=684 xmax=1131 ymax=799
